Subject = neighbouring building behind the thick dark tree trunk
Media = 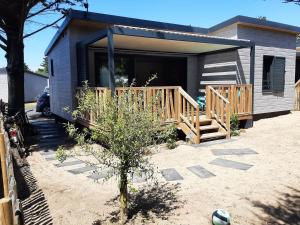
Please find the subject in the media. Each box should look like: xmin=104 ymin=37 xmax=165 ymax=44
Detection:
xmin=0 ymin=68 xmax=48 ymax=102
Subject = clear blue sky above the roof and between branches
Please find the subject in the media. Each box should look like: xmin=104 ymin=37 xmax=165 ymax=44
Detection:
xmin=0 ymin=0 xmax=300 ymax=70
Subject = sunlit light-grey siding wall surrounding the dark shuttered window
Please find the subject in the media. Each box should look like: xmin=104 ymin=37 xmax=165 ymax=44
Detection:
xmin=238 ymin=26 xmax=296 ymax=114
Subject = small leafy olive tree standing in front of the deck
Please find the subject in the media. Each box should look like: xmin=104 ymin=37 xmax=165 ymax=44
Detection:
xmin=57 ymin=82 xmax=174 ymax=223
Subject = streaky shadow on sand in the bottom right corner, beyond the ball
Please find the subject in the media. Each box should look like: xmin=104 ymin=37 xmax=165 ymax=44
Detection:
xmin=252 ymin=187 xmax=300 ymax=225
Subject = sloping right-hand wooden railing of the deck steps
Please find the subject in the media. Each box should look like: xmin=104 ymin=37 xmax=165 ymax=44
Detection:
xmin=206 ymin=86 xmax=231 ymax=137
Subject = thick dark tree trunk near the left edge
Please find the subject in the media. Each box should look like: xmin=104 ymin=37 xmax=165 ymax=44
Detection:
xmin=6 ymin=30 xmax=24 ymax=115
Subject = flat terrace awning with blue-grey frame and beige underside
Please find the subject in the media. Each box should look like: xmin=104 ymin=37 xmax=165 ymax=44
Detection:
xmin=84 ymin=25 xmax=253 ymax=54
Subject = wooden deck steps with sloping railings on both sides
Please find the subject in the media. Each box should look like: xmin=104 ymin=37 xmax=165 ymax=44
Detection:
xmin=177 ymin=88 xmax=230 ymax=144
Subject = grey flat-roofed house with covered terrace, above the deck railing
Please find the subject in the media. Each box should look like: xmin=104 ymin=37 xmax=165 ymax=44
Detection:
xmin=45 ymin=11 xmax=300 ymax=122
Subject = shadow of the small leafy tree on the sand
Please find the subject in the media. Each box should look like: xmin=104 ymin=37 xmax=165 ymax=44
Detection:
xmin=93 ymin=183 xmax=185 ymax=225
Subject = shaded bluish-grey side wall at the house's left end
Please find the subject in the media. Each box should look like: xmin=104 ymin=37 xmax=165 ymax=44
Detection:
xmin=48 ymin=22 xmax=105 ymax=120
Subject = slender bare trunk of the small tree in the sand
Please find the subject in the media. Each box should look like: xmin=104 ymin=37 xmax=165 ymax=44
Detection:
xmin=120 ymin=172 xmax=128 ymax=224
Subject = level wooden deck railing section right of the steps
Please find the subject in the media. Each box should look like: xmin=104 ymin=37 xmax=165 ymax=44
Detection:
xmin=212 ymin=84 xmax=252 ymax=119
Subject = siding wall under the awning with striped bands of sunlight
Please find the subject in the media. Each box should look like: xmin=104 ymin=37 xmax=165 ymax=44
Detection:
xmin=187 ymin=48 xmax=250 ymax=98
